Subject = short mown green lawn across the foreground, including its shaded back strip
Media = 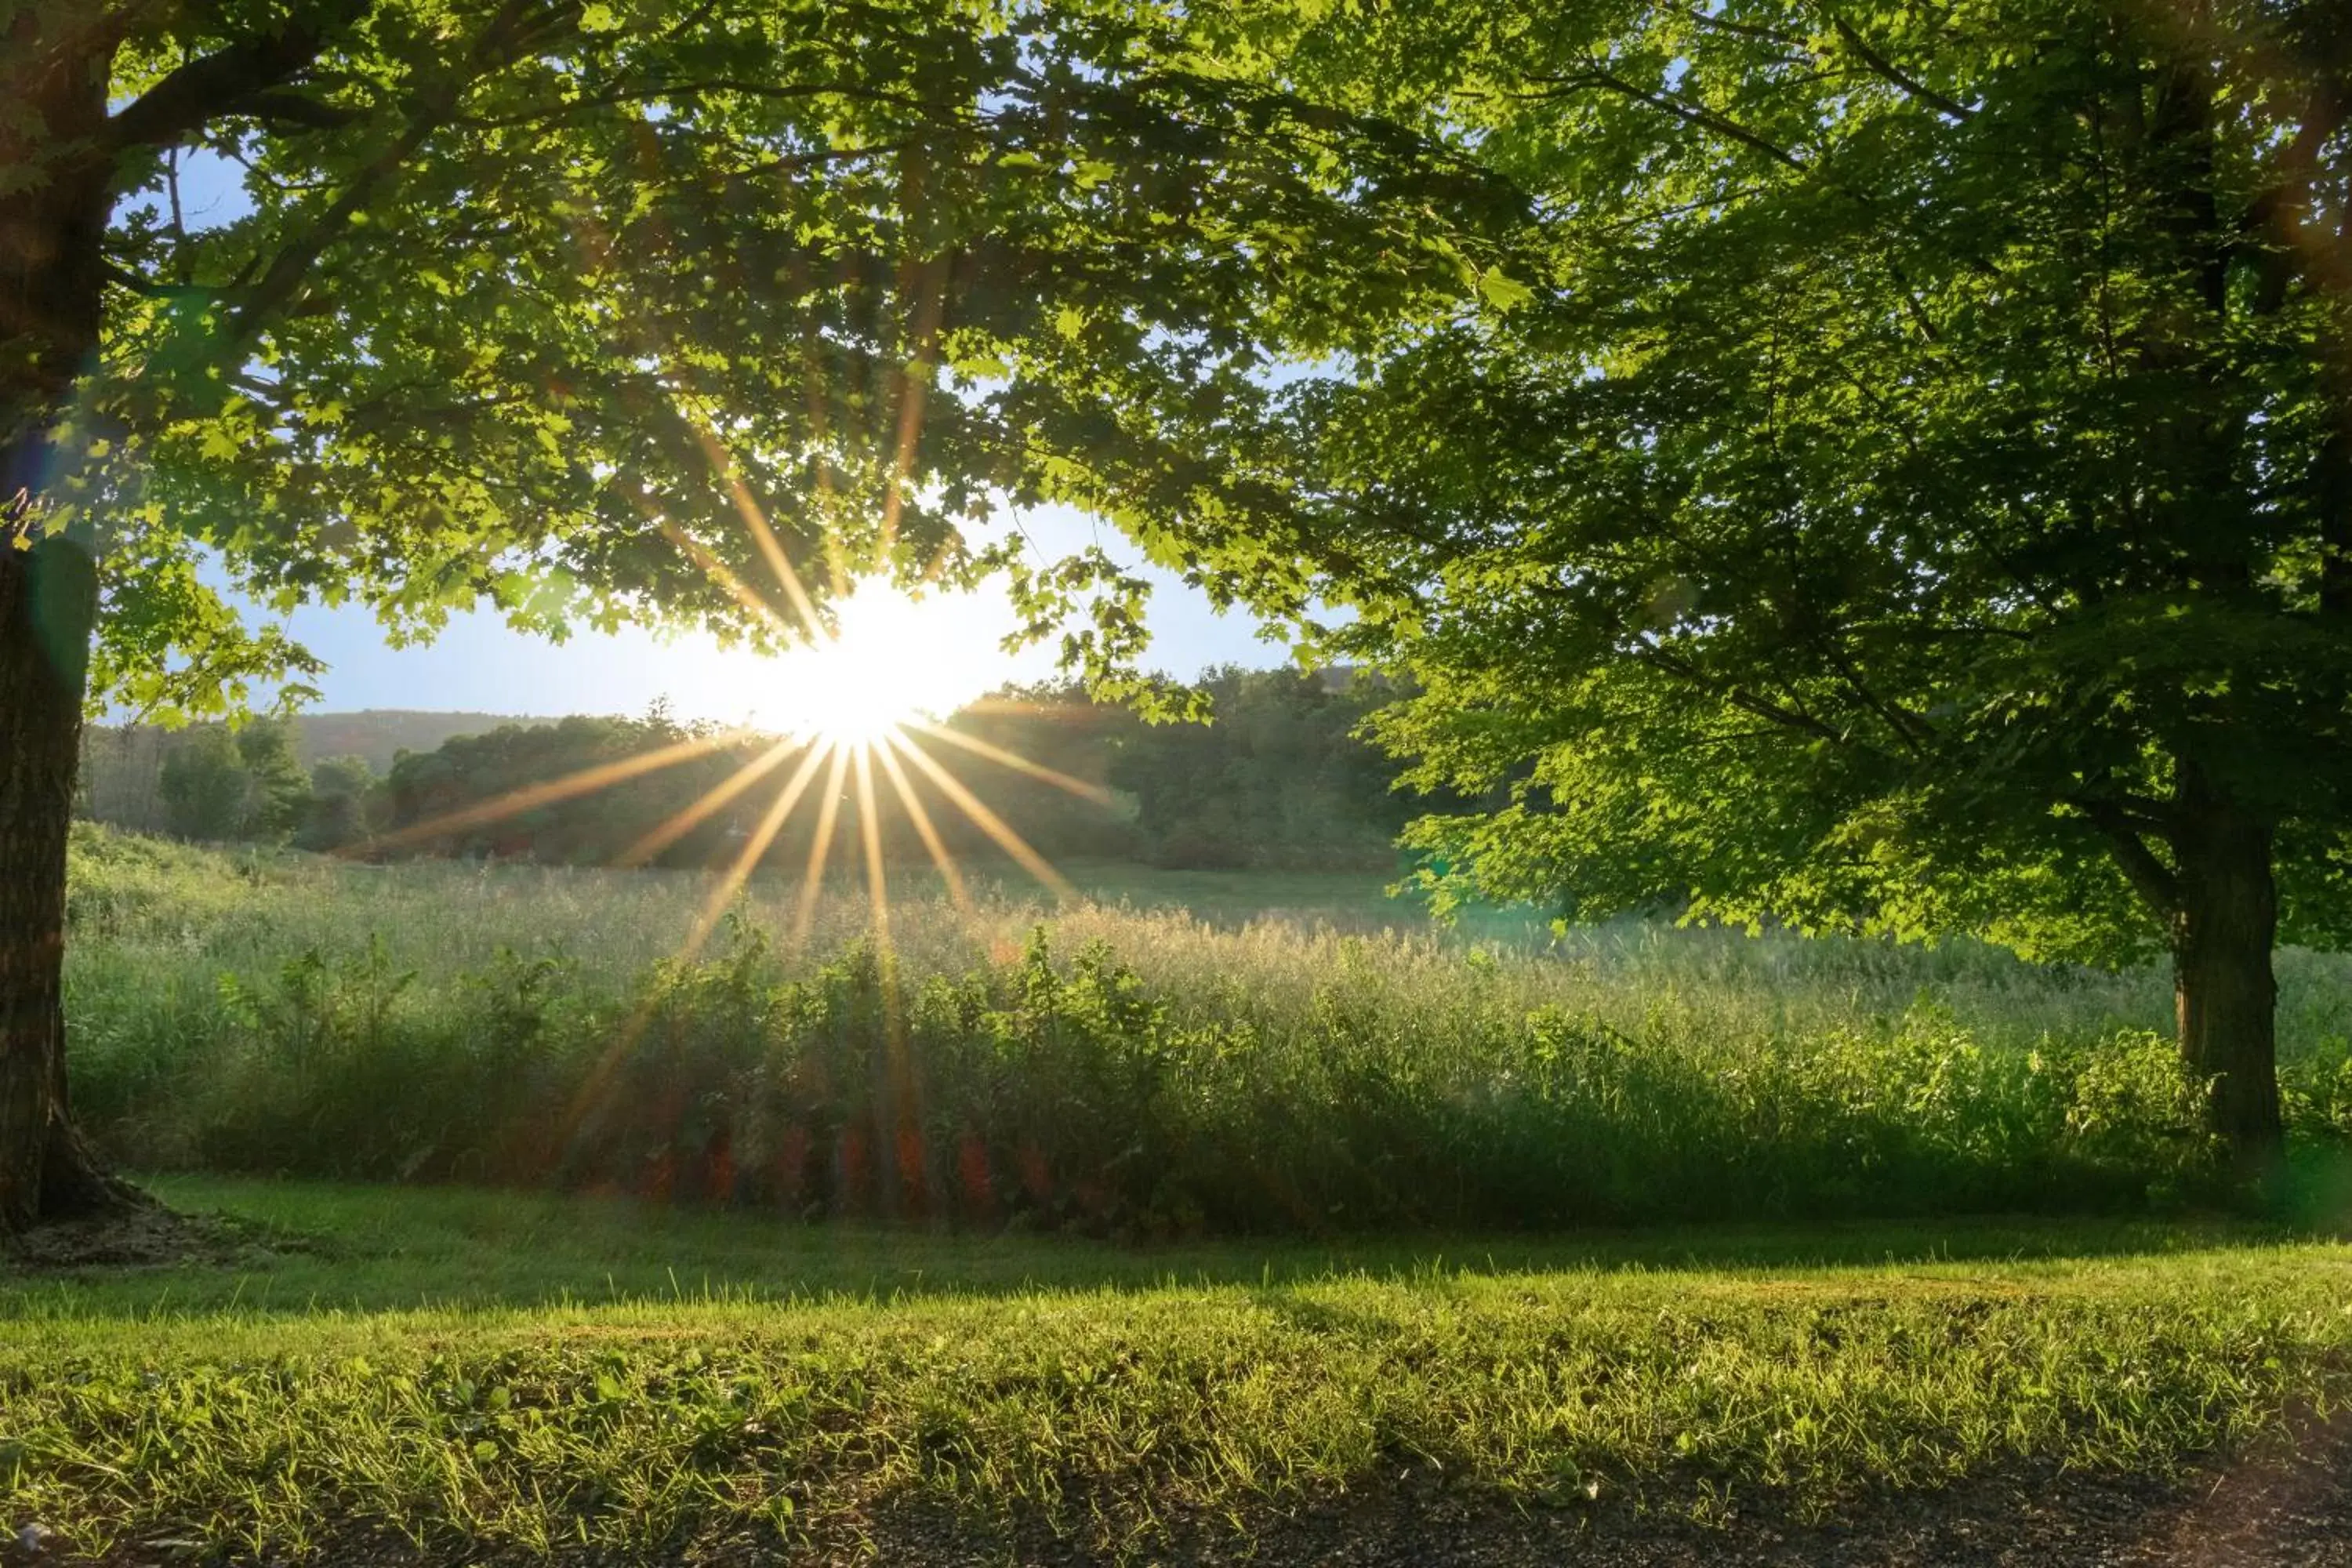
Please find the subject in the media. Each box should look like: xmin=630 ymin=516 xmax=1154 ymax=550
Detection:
xmin=0 ymin=1178 xmax=2352 ymax=1559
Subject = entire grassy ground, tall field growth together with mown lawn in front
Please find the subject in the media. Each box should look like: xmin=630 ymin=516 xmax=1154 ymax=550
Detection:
xmin=0 ymin=829 xmax=2352 ymax=1563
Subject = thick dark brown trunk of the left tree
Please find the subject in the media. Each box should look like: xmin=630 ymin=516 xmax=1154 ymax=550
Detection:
xmin=0 ymin=7 xmax=129 ymax=1234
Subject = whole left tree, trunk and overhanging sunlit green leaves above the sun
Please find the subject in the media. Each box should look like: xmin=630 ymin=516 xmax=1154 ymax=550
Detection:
xmin=0 ymin=0 xmax=1508 ymax=1225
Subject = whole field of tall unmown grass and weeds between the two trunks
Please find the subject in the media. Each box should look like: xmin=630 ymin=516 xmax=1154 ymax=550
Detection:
xmin=55 ymin=834 xmax=2352 ymax=1234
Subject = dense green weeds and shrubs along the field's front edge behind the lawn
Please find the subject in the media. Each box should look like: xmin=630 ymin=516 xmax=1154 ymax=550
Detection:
xmin=82 ymin=935 xmax=2258 ymax=1234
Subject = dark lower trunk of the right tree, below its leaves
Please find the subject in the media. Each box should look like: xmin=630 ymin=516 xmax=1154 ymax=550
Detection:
xmin=2173 ymin=801 xmax=2286 ymax=1178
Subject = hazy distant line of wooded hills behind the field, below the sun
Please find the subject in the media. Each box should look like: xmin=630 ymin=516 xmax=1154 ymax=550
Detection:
xmin=78 ymin=668 xmax=1428 ymax=869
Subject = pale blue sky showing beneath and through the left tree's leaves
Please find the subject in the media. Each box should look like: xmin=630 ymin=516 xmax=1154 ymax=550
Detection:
xmin=147 ymin=153 xmax=1284 ymax=722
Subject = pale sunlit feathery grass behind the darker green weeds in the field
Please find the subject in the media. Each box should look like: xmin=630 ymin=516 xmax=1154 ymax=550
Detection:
xmin=50 ymin=832 xmax=2352 ymax=1058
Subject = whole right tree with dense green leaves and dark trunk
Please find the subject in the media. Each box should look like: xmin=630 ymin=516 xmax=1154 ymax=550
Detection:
xmin=1077 ymin=0 xmax=2352 ymax=1166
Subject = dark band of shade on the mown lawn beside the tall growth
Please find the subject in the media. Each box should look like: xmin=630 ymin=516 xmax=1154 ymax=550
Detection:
xmin=0 ymin=1175 xmax=2340 ymax=1319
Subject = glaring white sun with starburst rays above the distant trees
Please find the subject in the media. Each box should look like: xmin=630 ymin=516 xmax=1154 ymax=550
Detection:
xmin=757 ymin=583 xmax=1007 ymax=748
